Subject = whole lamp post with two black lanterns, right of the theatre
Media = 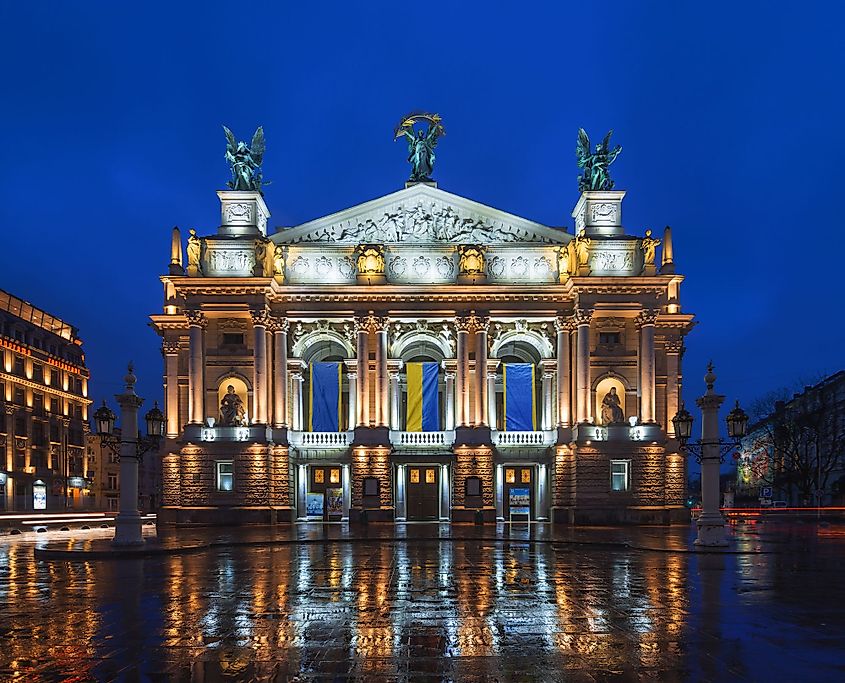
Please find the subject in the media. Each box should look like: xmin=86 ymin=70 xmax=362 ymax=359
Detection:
xmin=672 ymin=362 xmax=748 ymax=547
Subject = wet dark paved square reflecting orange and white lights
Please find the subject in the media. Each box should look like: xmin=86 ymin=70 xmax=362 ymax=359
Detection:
xmin=0 ymin=524 xmax=845 ymax=682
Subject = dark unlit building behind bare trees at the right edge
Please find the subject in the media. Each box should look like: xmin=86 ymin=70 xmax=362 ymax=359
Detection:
xmin=736 ymin=371 xmax=845 ymax=505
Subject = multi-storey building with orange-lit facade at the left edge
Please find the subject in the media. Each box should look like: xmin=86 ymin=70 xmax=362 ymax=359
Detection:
xmin=0 ymin=290 xmax=91 ymax=511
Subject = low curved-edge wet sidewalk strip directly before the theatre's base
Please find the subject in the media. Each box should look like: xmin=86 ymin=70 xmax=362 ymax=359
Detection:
xmin=29 ymin=522 xmax=779 ymax=562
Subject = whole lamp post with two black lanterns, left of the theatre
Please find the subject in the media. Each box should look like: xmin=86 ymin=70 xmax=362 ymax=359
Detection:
xmin=94 ymin=363 xmax=164 ymax=546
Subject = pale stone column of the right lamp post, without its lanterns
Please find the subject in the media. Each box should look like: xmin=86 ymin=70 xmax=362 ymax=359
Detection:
xmin=695 ymin=363 xmax=728 ymax=546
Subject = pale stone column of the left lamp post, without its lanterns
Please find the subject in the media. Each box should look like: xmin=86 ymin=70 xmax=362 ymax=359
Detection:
xmin=112 ymin=363 xmax=144 ymax=545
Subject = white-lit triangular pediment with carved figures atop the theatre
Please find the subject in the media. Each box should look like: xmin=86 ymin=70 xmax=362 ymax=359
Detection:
xmin=271 ymin=183 xmax=572 ymax=244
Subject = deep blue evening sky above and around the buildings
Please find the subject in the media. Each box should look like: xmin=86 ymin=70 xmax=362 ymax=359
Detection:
xmin=0 ymin=1 xmax=845 ymax=432
